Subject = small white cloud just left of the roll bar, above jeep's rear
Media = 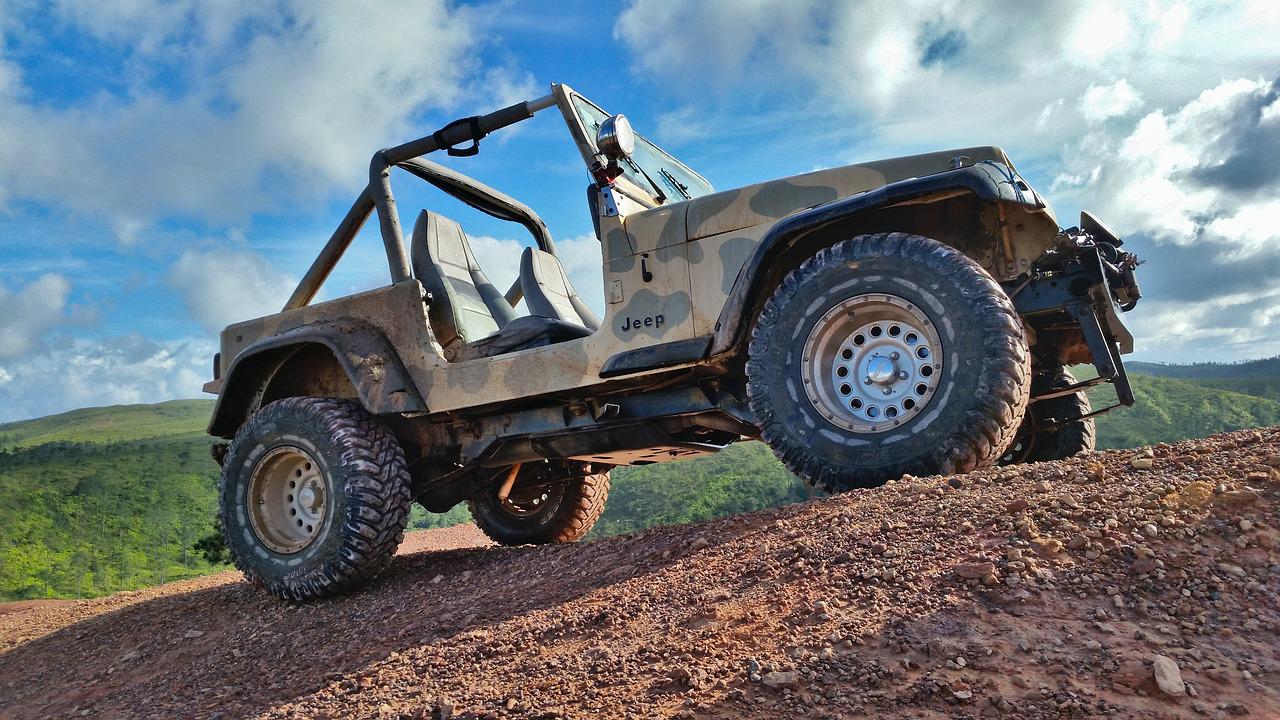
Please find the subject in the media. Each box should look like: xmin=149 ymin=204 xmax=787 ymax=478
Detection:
xmin=169 ymin=247 xmax=298 ymax=333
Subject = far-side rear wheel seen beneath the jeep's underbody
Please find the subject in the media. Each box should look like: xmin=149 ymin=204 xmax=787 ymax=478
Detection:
xmin=467 ymin=473 xmax=609 ymax=544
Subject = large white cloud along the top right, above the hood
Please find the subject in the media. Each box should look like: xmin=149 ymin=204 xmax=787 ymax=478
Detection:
xmin=614 ymin=0 xmax=1280 ymax=151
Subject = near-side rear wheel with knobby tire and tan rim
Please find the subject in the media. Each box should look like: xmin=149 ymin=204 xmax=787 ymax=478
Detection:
xmin=219 ymin=397 xmax=411 ymax=601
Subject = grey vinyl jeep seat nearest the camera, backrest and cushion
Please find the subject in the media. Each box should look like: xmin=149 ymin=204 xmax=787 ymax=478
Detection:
xmin=410 ymin=210 xmax=591 ymax=363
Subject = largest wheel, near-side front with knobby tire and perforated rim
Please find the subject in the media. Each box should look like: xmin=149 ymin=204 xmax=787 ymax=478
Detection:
xmin=746 ymin=233 xmax=1030 ymax=492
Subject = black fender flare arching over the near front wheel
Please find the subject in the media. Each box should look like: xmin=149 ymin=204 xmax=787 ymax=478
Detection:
xmin=709 ymin=163 xmax=1043 ymax=357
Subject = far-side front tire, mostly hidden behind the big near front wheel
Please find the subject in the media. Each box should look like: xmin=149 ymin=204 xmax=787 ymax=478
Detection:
xmin=1000 ymin=366 xmax=1097 ymax=465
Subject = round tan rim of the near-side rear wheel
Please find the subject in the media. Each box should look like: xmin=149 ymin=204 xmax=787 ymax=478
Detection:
xmin=248 ymin=446 xmax=328 ymax=555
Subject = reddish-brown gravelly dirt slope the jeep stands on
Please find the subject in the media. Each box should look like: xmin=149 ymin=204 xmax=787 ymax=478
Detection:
xmin=0 ymin=429 xmax=1280 ymax=719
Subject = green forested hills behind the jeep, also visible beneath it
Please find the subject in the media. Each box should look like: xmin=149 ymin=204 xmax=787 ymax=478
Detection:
xmin=0 ymin=359 xmax=1280 ymax=600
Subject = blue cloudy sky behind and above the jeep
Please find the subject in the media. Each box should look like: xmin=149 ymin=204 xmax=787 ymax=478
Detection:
xmin=0 ymin=0 xmax=1280 ymax=421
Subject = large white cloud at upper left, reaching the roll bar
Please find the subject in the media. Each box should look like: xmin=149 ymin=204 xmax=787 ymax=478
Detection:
xmin=0 ymin=0 xmax=488 ymax=235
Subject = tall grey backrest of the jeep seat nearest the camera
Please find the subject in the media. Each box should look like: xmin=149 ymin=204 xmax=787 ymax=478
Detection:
xmin=411 ymin=210 xmax=516 ymax=347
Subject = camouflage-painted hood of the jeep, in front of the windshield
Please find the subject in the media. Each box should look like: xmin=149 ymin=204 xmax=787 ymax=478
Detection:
xmin=686 ymin=146 xmax=1012 ymax=240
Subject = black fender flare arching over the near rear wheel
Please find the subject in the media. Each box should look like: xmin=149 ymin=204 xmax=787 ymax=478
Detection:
xmin=209 ymin=320 xmax=426 ymax=438
